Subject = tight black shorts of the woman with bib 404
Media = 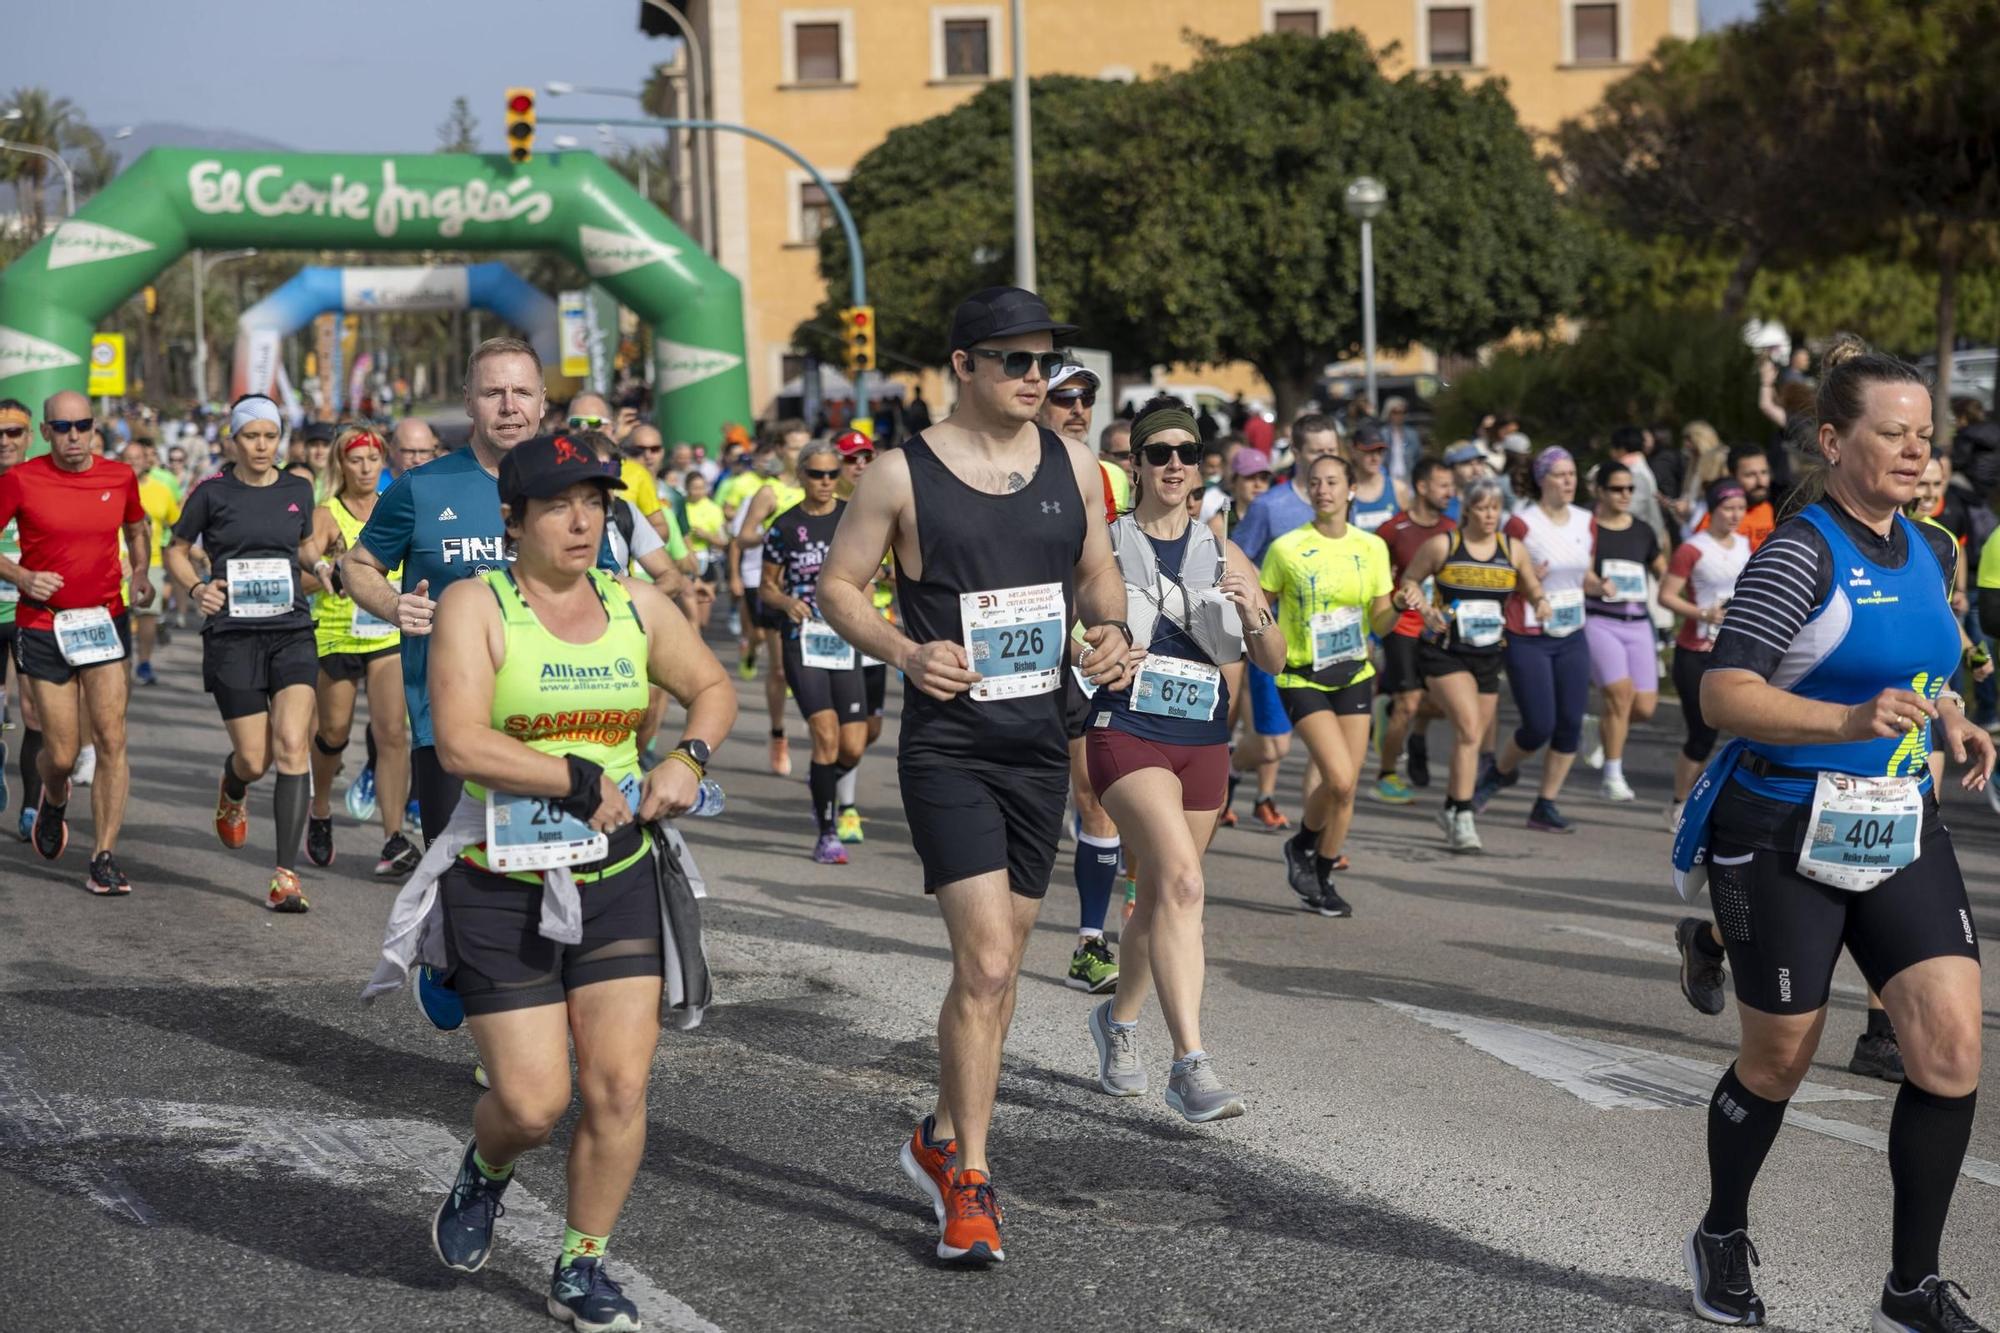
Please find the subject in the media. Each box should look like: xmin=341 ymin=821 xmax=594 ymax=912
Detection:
xmin=1708 ymin=785 xmax=1980 ymax=1013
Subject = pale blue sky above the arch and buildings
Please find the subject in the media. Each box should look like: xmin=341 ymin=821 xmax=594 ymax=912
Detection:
xmin=15 ymin=0 xmax=1756 ymax=152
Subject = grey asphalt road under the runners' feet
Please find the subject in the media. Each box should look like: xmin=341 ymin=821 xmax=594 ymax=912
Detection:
xmin=0 ymin=636 xmax=2000 ymax=1333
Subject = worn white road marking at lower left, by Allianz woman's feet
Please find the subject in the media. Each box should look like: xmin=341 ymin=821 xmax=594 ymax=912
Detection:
xmin=0 ymin=1049 xmax=722 ymax=1333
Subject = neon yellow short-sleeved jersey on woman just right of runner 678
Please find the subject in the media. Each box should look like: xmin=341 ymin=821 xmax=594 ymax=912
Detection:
xmin=1260 ymin=524 xmax=1394 ymax=691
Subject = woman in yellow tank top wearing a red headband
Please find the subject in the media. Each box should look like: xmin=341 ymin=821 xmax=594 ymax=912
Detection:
xmin=306 ymin=426 xmax=418 ymax=877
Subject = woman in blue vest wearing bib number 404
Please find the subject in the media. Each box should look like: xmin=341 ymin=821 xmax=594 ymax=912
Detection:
xmin=1684 ymin=336 xmax=1994 ymax=1333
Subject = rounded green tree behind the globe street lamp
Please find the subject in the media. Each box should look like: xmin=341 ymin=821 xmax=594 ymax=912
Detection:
xmin=1084 ymin=32 xmax=1580 ymax=416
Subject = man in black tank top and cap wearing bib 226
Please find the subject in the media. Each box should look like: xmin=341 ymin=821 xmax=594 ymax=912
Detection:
xmin=820 ymin=286 xmax=1132 ymax=1263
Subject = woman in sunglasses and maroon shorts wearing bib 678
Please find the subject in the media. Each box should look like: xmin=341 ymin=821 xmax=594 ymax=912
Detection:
xmin=1084 ymin=398 xmax=1284 ymax=1121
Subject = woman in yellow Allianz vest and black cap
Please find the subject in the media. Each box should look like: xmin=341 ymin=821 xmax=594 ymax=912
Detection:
xmin=420 ymin=434 xmax=736 ymax=1329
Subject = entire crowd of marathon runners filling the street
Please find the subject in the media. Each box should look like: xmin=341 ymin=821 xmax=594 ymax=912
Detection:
xmin=0 ymin=288 xmax=2000 ymax=1331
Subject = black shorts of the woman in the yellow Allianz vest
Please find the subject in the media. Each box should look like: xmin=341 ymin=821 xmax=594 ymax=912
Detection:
xmin=438 ymin=844 xmax=666 ymax=1015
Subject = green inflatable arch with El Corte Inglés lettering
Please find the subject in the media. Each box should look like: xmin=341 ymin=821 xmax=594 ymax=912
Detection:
xmin=0 ymin=148 xmax=750 ymax=442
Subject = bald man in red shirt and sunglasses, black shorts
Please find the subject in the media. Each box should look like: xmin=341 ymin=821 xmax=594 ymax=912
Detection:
xmin=0 ymin=392 xmax=152 ymax=895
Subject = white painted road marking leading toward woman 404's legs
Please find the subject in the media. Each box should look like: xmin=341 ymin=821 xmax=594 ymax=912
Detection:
xmin=1376 ymin=999 xmax=2000 ymax=1187
